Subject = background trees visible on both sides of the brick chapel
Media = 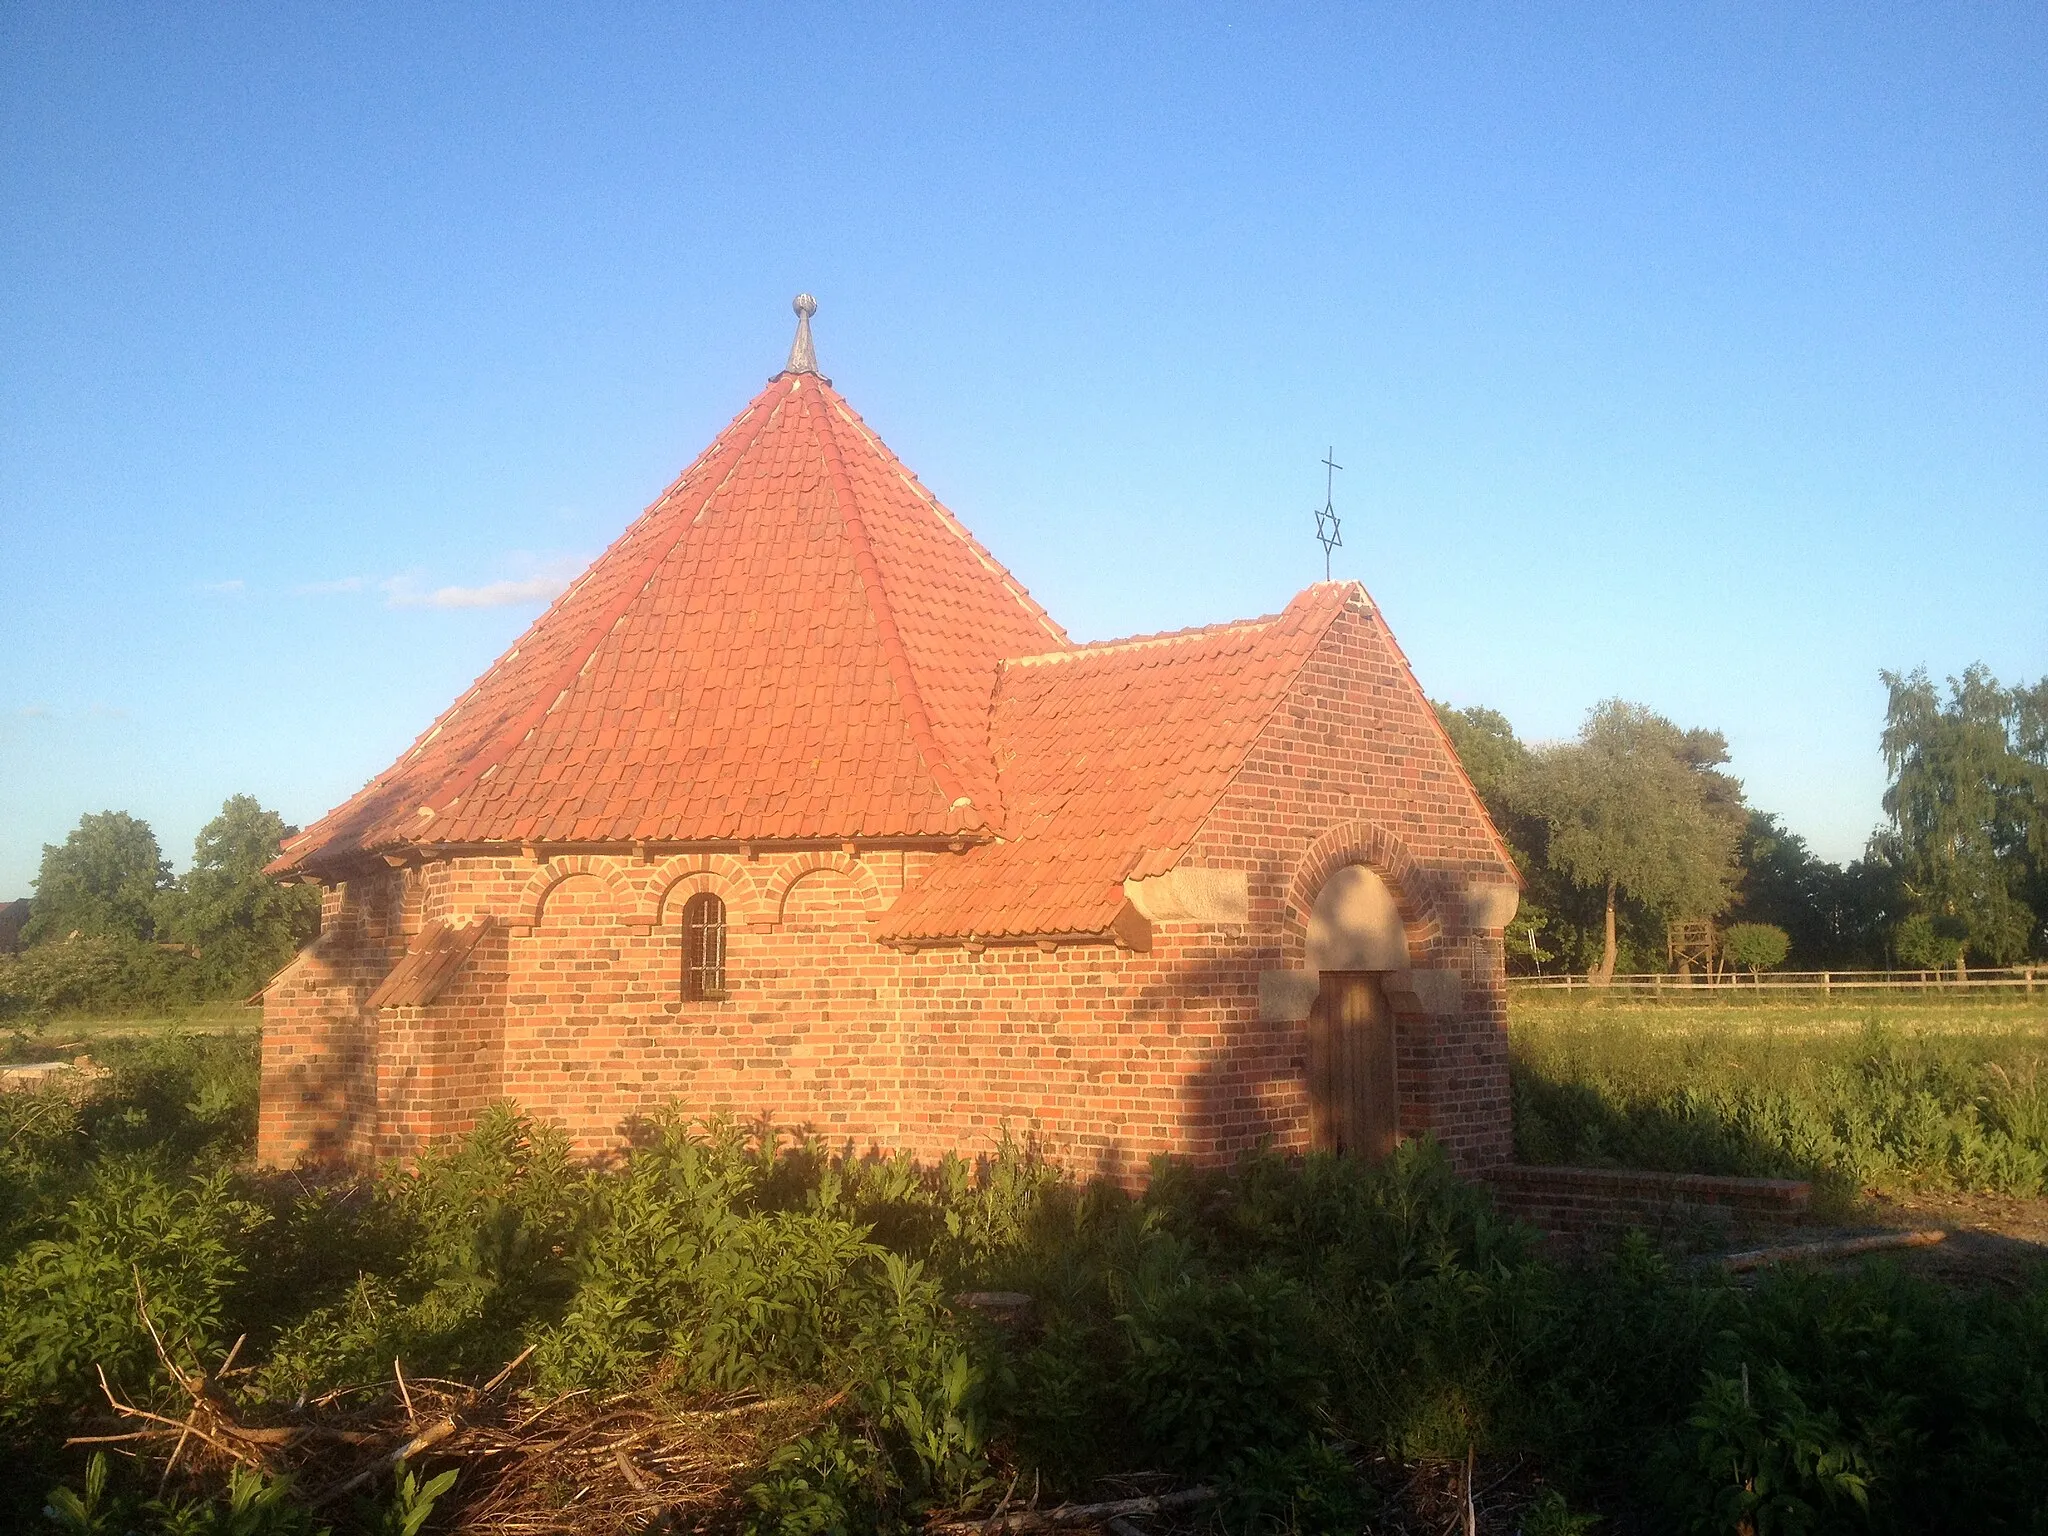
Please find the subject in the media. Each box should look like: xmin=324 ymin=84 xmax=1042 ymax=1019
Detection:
xmin=0 ymin=666 xmax=2048 ymax=1018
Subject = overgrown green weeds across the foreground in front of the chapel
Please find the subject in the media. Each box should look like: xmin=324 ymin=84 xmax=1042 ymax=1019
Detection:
xmin=12 ymin=1036 xmax=2048 ymax=1536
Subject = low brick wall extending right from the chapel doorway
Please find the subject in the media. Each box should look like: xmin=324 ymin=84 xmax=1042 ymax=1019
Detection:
xmin=1485 ymin=1163 xmax=1812 ymax=1237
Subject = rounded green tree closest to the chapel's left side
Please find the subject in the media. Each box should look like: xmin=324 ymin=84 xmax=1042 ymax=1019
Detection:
xmin=162 ymin=795 xmax=319 ymax=995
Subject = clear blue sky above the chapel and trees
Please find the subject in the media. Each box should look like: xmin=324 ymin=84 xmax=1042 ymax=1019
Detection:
xmin=0 ymin=4 xmax=2048 ymax=897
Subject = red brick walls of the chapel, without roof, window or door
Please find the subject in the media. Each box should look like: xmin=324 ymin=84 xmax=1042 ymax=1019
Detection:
xmin=260 ymin=608 xmax=1509 ymax=1180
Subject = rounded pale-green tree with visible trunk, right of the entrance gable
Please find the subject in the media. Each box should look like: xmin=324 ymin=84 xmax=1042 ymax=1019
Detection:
xmin=1520 ymin=698 xmax=1743 ymax=985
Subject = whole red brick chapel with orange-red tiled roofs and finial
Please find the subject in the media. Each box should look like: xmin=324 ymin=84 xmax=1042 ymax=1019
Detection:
xmin=260 ymin=297 xmax=1520 ymax=1180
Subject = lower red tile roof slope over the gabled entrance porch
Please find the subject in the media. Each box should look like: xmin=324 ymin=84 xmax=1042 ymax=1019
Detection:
xmin=877 ymin=582 xmax=1356 ymax=942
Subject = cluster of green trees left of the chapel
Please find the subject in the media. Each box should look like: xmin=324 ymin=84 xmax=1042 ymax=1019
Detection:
xmin=0 ymin=795 xmax=319 ymax=1020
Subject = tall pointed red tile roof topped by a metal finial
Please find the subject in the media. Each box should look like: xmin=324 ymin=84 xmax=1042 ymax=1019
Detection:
xmin=272 ymin=297 xmax=1067 ymax=874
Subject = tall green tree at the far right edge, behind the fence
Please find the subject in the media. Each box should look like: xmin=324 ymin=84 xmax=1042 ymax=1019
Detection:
xmin=1878 ymin=666 xmax=2048 ymax=965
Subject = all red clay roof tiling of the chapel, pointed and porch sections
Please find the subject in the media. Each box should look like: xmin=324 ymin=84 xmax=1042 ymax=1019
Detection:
xmin=272 ymin=352 xmax=1507 ymax=950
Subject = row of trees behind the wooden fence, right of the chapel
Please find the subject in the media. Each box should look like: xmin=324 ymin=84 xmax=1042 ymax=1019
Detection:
xmin=1436 ymin=666 xmax=2048 ymax=981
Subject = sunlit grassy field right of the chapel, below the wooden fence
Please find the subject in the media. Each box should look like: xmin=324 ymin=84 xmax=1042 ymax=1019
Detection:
xmin=1509 ymin=991 xmax=2048 ymax=1204
